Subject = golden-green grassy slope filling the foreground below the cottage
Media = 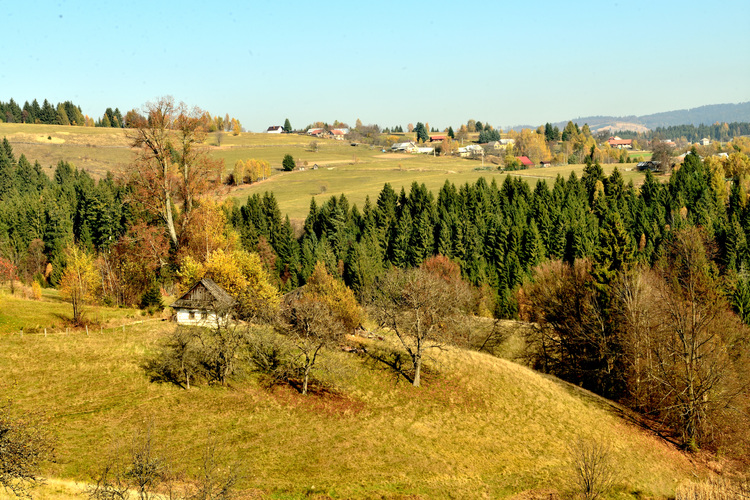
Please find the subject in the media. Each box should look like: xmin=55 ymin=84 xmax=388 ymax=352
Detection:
xmin=0 ymin=292 xmax=704 ymax=498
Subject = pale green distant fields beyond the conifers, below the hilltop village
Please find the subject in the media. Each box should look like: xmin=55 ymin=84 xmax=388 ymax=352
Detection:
xmin=0 ymin=123 xmax=656 ymax=219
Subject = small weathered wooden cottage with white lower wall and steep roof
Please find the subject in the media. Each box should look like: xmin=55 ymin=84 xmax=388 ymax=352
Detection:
xmin=170 ymin=276 xmax=237 ymax=326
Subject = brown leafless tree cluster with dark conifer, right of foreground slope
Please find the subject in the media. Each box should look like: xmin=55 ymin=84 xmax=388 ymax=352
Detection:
xmin=521 ymin=225 xmax=750 ymax=455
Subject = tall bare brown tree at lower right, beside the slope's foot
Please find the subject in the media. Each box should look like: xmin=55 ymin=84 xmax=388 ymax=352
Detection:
xmin=651 ymin=228 xmax=747 ymax=449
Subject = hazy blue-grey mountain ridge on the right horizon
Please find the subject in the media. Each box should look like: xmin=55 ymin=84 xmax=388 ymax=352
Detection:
xmin=552 ymin=101 xmax=750 ymax=132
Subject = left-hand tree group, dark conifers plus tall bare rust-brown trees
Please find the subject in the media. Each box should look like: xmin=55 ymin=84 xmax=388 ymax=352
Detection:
xmin=0 ymin=99 xmax=231 ymax=319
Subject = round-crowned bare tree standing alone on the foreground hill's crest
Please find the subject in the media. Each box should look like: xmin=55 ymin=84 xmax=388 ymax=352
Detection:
xmin=373 ymin=268 xmax=471 ymax=387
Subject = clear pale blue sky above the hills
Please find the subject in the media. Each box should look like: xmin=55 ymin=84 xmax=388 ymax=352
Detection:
xmin=0 ymin=0 xmax=750 ymax=131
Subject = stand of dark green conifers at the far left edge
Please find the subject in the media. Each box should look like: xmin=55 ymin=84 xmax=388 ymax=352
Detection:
xmin=0 ymin=140 xmax=132 ymax=285
